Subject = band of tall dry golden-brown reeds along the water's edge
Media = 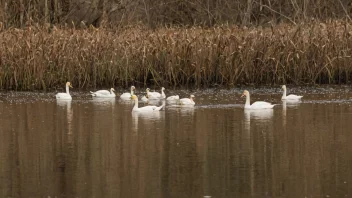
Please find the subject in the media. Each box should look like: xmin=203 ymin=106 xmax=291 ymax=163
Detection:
xmin=0 ymin=21 xmax=352 ymax=90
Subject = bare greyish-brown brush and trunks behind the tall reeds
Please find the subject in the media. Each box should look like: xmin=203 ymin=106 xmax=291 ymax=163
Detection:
xmin=0 ymin=0 xmax=352 ymax=28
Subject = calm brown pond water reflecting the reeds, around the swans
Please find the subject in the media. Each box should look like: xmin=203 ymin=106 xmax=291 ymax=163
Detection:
xmin=0 ymin=87 xmax=352 ymax=198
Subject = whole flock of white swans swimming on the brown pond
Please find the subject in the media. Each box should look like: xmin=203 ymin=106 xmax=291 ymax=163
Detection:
xmin=56 ymin=82 xmax=303 ymax=112
